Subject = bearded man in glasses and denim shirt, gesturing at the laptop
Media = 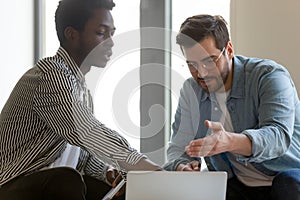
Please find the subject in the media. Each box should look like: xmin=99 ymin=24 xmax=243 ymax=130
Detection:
xmin=164 ymin=15 xmax=300 ymax=200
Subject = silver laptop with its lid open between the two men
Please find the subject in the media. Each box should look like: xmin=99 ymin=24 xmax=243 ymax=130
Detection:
xmin=126 ymin=171 xmax=227 ymax=200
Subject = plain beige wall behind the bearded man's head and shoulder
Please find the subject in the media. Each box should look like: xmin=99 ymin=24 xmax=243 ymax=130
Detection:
xmin=230 ymin=0 xmax=300 ymax=94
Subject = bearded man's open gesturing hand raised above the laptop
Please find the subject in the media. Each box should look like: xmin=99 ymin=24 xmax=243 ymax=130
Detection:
xmin=185 ymin=120 xmax=231 ymax=157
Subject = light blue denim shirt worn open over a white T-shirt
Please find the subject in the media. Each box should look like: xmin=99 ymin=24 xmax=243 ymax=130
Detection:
xmin=164 ymin=56 xmax=300 ymax=177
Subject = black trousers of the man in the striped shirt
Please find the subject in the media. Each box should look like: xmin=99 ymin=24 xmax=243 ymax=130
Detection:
xmin=0 ymin=167 xmax=125 ymax=200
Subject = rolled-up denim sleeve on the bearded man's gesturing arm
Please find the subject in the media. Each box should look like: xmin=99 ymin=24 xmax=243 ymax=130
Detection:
xmin=240 ymin=66 xmax=297 ymax=163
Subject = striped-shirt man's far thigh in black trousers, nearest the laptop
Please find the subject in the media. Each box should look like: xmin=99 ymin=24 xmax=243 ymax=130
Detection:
xmin=83 ymin=175 xmax=125 ymax=200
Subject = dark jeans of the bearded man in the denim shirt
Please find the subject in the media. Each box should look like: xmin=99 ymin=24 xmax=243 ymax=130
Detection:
xmin=226 ymin=169 xmax=300 ymax=200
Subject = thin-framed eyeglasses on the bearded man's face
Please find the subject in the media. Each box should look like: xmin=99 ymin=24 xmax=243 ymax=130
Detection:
xmin=187 ymin=47 xmax=225 ymax=73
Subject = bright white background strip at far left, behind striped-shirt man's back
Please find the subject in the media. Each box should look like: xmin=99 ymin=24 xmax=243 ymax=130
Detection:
xmin=0 ymin=0 xmax=34 ymax=111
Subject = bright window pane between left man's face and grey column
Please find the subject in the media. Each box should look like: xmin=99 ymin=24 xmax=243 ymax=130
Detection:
xmin=90 ymin=0 xmax=140 ymax=150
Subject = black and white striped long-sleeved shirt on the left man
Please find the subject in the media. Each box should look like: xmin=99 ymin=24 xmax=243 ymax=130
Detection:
xmin=0 ymin=47 xmax=144 ymax=185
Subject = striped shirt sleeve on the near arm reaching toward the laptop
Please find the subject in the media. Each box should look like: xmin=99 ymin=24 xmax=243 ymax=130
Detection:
xmin=34 ymin=60 xmax=144 ymax=170
